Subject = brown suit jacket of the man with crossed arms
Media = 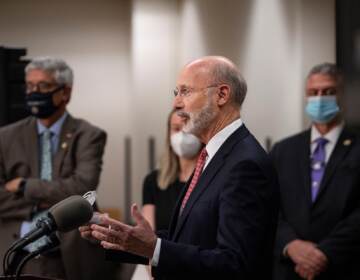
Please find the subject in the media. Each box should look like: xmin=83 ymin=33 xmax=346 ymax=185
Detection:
xmin=0 ymin=115 xmax=116 ymax=279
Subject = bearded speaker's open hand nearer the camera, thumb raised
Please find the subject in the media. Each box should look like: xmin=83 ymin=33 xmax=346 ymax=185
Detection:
xmin=90 ymin=204 xmax=157 ymax=259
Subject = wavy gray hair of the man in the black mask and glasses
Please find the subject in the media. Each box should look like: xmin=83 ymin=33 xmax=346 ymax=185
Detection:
xmin=25 ymin=57 xmax=74 ymax=87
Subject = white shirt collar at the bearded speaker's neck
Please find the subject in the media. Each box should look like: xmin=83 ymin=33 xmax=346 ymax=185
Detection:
xmin=206 ymin=118 xmax=243 ymax=159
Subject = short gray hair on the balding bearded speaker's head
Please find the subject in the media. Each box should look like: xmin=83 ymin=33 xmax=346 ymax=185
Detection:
xmin=212 ymin=61 xmax=247 ymax=106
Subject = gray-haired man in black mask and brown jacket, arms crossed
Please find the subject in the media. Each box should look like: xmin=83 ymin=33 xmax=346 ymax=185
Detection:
xmin=0 ymin=58 xmax=114 ymax=279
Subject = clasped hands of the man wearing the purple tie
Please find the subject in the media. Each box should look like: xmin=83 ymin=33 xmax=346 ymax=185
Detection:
xmin=287 ymin=240 xmax=328 ymax=280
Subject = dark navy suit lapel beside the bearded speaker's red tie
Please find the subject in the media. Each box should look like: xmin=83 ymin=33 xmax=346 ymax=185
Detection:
xmin=171 ymin=125 xmax=249 ymax=240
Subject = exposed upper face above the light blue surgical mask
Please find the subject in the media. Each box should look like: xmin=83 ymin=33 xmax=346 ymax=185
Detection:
xmin=306 ymin=74 xmax=340 ymax=101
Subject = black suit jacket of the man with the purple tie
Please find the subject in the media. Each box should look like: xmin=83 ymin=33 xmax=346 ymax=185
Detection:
xmin=271 ymin=129 xmax=360 ymax=280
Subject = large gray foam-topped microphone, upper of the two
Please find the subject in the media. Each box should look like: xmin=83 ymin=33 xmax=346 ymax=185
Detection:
xmin=10 ymin=195 xmax=93 ymax=251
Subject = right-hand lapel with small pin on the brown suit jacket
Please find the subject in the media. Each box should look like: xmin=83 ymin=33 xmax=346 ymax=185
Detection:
xmin=53 ymin=114 xmax=76 ymax=178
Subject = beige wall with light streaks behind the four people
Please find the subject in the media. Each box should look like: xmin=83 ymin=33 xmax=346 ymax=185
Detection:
xmin=0 ymin=0 xmax=335 ymax=214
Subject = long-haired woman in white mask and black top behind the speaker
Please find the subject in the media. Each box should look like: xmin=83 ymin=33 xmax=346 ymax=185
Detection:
xmin=132 ymin=111 xmax=202 ymax=280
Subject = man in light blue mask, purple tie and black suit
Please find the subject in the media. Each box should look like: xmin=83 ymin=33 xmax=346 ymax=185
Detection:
xmin=271 ymin=63 xmax=360 ymax=280
